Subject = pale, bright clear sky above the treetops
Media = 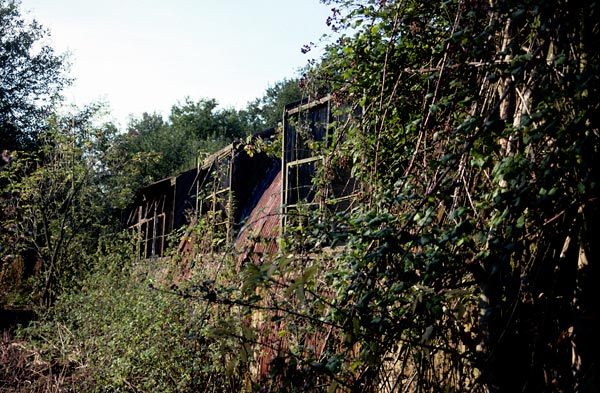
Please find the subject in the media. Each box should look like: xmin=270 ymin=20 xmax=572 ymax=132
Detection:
xmin=21 ymin=0 xmax=330 ymax=127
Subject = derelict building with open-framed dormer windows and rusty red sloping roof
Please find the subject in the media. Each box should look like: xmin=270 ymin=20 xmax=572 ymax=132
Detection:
xmin=126 ymin=96 xmax=357 ymax=259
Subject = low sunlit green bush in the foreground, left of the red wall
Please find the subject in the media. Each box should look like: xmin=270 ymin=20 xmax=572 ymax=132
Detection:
xmin=14 ymin=237 xmax=251 ymax=392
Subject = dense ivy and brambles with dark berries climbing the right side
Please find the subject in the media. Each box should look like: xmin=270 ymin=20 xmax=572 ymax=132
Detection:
xmin=251 ymin=1 xmax=600 ymax=391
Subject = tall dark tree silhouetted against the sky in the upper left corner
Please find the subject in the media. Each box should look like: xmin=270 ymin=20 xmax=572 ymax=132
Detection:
xmin=0 ymin=0 xmax=70 ymax=150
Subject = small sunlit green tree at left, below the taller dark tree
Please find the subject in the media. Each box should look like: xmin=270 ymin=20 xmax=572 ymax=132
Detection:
xmin=0 ymin=106 xmax=118 ymax=306
